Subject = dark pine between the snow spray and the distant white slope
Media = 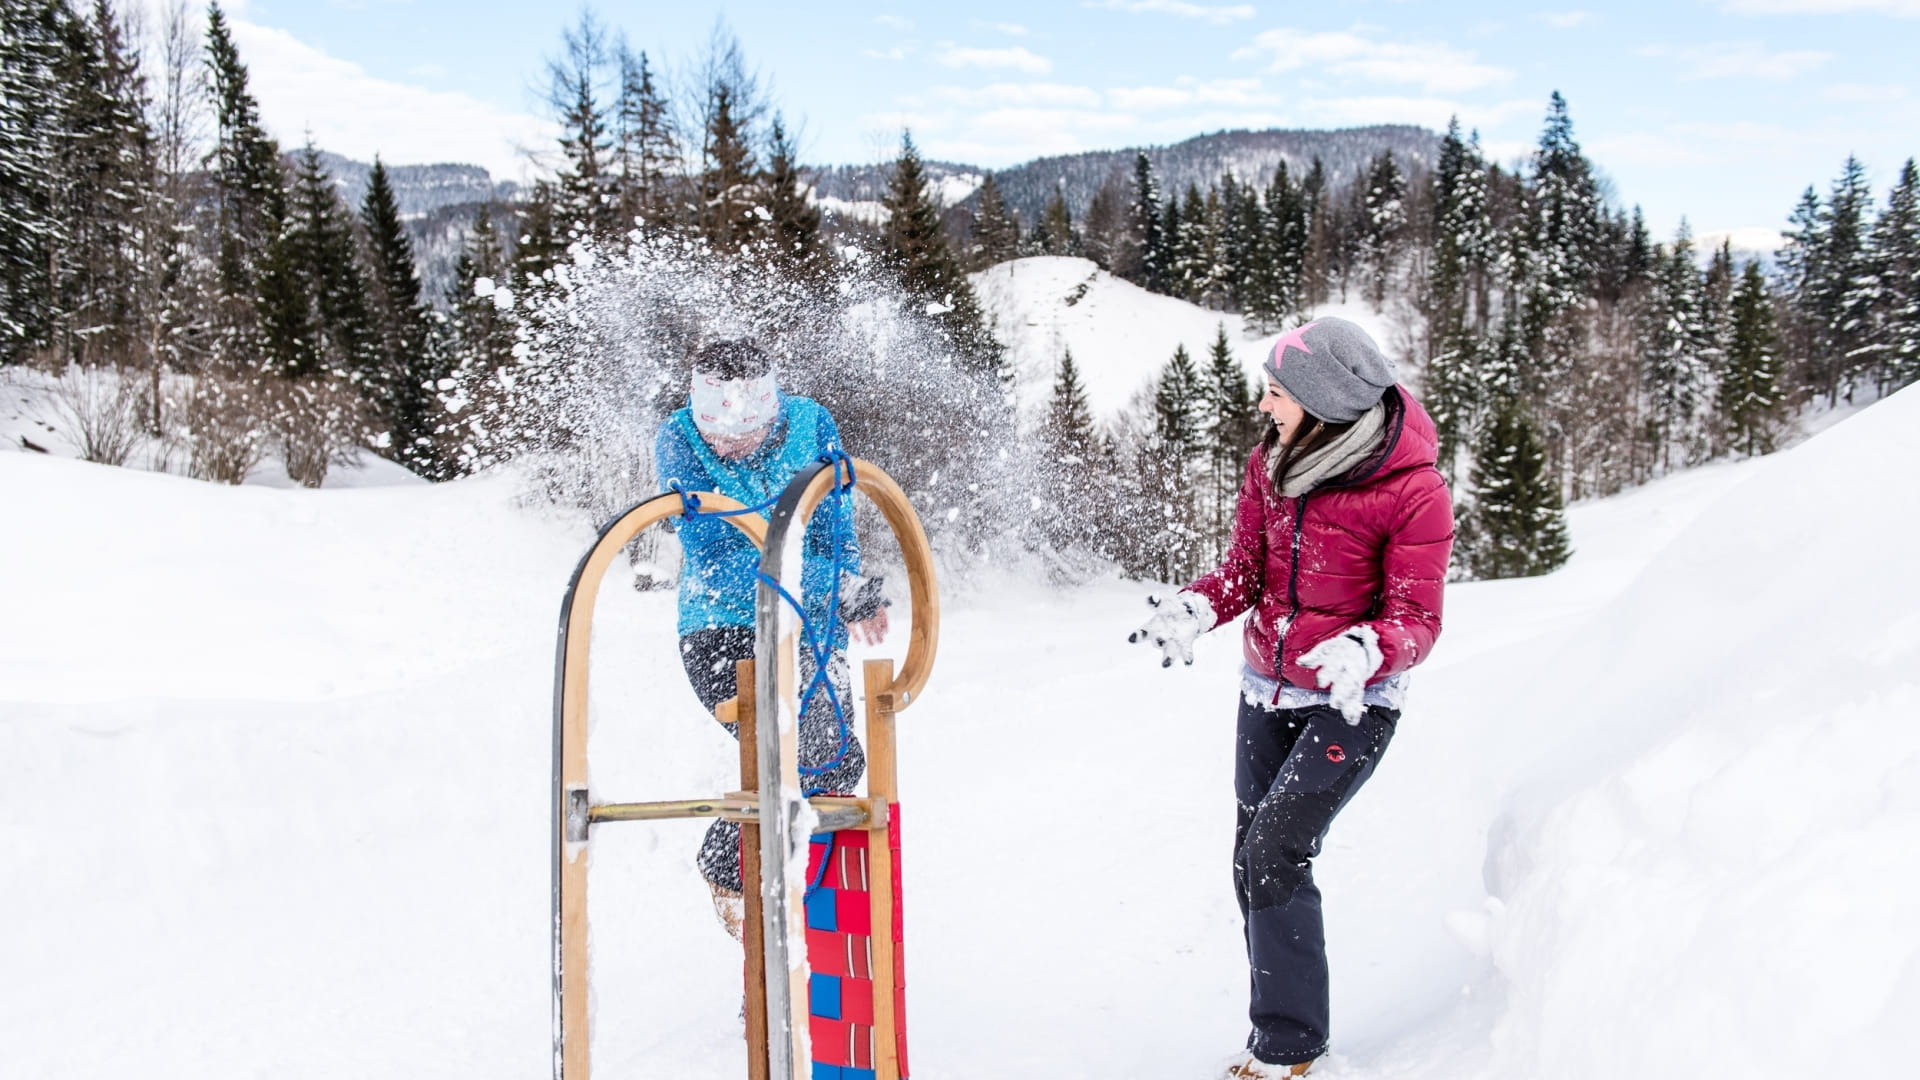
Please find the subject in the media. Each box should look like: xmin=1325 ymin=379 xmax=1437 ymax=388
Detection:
xmin=883 ymin=133 xmax=1006 ymax=384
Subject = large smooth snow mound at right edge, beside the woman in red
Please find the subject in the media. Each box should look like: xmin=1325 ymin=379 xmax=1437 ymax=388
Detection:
xmin=1486 ymin=382 xmax=1920 ymax=1078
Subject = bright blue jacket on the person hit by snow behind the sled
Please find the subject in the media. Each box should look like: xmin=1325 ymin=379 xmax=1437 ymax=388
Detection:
xmin=653 ymin=394 xmax=860 ymax=650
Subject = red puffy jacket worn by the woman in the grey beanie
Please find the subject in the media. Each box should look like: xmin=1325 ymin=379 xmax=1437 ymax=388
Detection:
xmin=1187 ymin=386 xmax=1453 ymax=690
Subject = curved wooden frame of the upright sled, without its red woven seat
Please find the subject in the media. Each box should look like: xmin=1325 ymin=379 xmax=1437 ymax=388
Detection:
xmin=551 ymin=459 xmax=939 ymax=1080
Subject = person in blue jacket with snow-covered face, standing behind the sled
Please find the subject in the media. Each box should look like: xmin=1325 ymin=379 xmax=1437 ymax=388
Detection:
xmin=653 ymin=340 xmax=887 ymax=938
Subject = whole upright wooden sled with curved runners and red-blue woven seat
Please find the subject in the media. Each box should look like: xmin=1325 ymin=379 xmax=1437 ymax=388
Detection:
xmin=553 ymin=455 xmax=939 ymax=1080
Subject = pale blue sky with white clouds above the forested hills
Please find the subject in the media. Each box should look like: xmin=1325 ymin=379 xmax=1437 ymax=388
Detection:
xmin=183 ymin=0 xmax=1920 ymax=244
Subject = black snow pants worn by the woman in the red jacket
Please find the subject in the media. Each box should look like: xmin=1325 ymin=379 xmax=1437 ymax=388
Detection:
xmin=1233 ymin=696 xmax=1400 ymax=1065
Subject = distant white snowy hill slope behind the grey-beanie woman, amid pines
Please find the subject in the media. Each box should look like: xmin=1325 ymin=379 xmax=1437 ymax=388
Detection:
xmin=972 ymin=256 xmax=1396 ymax=421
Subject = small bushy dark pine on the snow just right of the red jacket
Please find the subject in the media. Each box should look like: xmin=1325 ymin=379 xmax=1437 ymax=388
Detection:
xmin=1469 ymin=398 xmax=1572 ymax=578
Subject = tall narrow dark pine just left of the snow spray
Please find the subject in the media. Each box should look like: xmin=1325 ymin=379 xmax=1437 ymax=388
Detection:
xmin=361 ymin=158 xmax=447 ymax=470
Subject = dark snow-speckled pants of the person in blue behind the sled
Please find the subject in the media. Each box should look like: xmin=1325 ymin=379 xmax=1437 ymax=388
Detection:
xmin=680 ymin=626 xmax=866 ymax=892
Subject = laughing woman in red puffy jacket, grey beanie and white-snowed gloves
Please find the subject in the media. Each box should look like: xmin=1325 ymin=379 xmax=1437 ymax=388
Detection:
xmin=1133 ymin=319 xmax=1453 ymax=1080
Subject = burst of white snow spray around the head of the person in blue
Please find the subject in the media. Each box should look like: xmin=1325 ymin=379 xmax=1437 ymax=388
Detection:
xmin=442 ymin=234 xmax=1035 ymax=571
